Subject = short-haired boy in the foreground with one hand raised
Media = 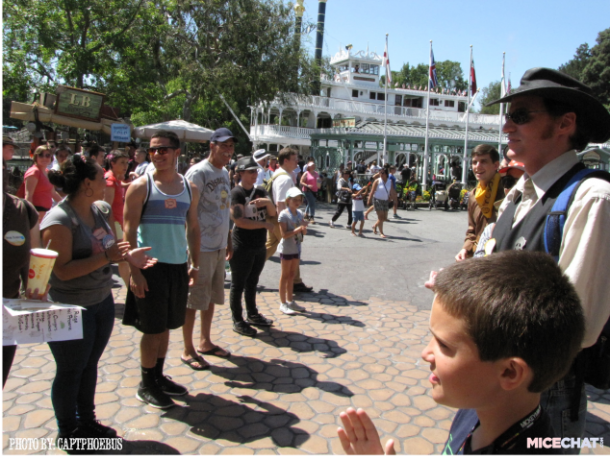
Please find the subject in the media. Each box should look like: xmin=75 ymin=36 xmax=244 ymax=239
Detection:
xmin=338 ymin=251 xmax=585 ymax=456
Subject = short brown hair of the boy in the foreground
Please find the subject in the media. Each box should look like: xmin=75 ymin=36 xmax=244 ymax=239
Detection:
xmin=434 ymin=251 xmax=585 ymax=393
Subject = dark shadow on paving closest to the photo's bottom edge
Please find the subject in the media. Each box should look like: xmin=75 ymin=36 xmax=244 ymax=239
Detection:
xmin=164 ymin=394 xmax=310 ymax=448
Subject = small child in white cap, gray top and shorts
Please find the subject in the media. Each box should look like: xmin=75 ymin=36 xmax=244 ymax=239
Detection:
xmin=278 ymin=187 xmax=307 ymax=315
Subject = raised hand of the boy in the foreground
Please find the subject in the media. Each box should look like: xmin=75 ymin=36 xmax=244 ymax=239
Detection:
xmin=337 ymin=408 xmax=396 ymax=456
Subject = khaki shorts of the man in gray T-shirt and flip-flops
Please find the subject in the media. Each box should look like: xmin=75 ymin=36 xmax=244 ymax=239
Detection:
xmin=188 ymin=249 xmax=227 ymax=312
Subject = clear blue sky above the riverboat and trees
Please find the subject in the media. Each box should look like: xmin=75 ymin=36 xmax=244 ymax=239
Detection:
xmin=304 ymin=0 xmax=610 ymax=105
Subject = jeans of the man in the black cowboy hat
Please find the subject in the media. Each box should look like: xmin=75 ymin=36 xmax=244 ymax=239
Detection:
xmin=541 ymin=378 xmax=587 ymax=456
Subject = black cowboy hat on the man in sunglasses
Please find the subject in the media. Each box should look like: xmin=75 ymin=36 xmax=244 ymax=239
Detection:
xmin=487 ymin=67 xmax=610 ymax=143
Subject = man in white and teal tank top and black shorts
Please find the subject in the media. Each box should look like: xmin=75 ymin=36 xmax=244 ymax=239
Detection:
xmin=123 ymin=132 xmax=200 ymax=409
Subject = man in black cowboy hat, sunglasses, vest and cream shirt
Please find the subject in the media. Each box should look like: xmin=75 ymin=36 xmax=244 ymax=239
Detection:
xmin=490 ymin=68 xmax=610 ymax=454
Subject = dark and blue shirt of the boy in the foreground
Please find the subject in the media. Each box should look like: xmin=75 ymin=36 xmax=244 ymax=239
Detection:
xmin=443 ymin=407 xmax=564 ymax=456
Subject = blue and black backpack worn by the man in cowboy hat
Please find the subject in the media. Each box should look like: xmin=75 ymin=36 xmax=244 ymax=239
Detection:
xmin=544 ymin=169 xmax=610 ymax=391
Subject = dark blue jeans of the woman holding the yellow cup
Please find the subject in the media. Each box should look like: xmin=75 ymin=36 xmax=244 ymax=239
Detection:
xmin=49 ymin=295 xmax=114 ymax=435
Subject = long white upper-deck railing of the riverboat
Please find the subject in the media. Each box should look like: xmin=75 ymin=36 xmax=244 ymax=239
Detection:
xmin=264 ymin=94 xmax=500 ymax=126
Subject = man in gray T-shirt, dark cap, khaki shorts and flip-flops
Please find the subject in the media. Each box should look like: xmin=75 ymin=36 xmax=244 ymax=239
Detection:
xmin=182 ymin=128 xmax=236 ymax=371
